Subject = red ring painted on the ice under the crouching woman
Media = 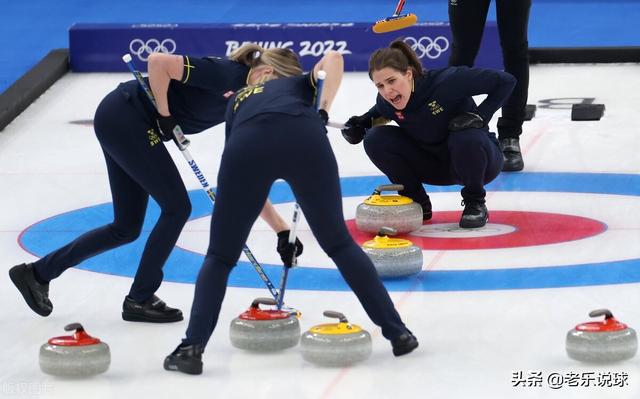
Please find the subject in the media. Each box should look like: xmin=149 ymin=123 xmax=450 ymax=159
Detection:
xmin=346 ymin=210 xmax=607 ymax=250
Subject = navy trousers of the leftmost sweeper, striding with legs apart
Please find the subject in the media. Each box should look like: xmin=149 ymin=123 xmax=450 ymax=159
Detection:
xmin=34 ymin=84 xmax=191 ymax=302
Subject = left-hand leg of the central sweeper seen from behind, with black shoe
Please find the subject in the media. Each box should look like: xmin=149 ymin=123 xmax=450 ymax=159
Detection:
xmin=164 ymin=118 xmax=277 ymax=374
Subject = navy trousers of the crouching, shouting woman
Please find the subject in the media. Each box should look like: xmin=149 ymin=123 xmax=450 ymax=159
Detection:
xmin=364 ymin=126 xmax=503 ymax=208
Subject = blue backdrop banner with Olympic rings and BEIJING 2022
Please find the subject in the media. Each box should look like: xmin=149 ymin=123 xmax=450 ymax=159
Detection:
xmin=69 ymin=22 xmax=502 ymax=72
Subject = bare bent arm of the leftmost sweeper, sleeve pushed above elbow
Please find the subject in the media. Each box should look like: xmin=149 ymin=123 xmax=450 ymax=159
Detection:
xmin=147 ymin=53 xmax=184 ymax=116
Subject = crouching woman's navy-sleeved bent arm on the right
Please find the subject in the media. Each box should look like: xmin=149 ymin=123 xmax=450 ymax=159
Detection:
xmin=445 ymin=67 xmax=516 ymax=123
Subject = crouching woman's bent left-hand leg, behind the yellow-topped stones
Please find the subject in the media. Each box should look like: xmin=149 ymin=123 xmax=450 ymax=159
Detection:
xmin=364 ymin=126 xmax=453 ymax=220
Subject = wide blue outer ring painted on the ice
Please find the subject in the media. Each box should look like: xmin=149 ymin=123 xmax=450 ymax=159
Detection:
xmin=19 ymin=173 xmax=640 ymax=291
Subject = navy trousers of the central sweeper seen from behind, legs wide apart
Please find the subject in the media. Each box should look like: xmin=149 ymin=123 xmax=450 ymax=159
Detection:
xmin=183 ymin=113 xmax=407 ymax=345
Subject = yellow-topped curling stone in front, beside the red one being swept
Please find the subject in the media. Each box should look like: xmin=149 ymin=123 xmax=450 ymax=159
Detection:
xmin=300 ymin=310 xmax=371 ymax=367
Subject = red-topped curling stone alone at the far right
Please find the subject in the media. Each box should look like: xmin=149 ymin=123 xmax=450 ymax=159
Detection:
xmin=566 ymin=309 xmax=638 ymax=363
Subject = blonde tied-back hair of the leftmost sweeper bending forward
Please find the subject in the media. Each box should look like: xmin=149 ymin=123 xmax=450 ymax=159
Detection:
xmin=229 ymin=43 xmax=302 ymax=83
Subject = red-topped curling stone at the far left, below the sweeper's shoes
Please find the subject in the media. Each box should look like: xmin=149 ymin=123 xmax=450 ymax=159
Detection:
xmin=40 ymin=323 xmax=111 ymax=377
